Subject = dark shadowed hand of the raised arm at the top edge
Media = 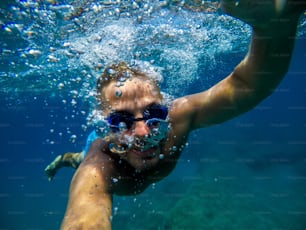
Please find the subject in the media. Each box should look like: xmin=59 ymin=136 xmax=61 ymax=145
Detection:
xmin=221 ymin=0 xmax=306 ymax=30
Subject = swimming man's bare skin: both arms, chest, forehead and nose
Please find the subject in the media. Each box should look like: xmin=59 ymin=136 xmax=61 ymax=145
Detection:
xmin=61 ymin=0 xmax=306 ymax=229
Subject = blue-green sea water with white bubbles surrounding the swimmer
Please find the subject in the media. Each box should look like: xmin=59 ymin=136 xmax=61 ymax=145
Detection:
xmin=0 ymin=1 xmax=306 ymax=230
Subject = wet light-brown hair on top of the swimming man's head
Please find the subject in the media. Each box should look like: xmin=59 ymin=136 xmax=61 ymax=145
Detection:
xmin=97 ymin=62 xmax=159 ymax=108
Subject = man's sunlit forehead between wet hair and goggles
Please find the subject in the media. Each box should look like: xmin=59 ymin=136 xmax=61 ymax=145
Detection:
xmin=102 ymin=78 xmax=162 ymax=112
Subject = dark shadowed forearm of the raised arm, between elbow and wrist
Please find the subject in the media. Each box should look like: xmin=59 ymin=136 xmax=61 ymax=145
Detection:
xmin=232 ymin=14 xmax=298 ymax=101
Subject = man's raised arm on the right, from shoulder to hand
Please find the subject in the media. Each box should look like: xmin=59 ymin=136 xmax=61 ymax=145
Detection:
xmin=173 ymin=0 xmax=306 ymax=130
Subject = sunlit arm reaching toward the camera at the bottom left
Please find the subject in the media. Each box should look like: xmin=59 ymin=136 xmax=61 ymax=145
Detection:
xmin=61 ymin=139 xmax=112 ymax=230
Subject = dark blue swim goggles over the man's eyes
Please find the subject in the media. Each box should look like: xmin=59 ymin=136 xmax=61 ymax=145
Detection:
xmin=107 ymin=104 xmax=168 ymax=132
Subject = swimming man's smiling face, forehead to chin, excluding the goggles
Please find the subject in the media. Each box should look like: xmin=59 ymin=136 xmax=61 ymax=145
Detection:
xmin=102 ymin=78 xmax=166 ymax=171
